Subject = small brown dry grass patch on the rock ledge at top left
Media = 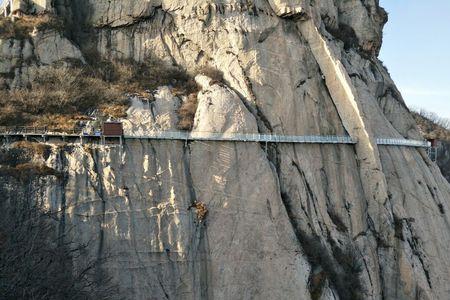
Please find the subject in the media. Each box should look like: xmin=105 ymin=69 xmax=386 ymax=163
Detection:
xmin=0 ymin=14 xmax=64 ymax=40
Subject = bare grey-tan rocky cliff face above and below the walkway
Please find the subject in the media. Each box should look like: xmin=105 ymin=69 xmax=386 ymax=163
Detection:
xmin=0 ymin=0 xmax=450 ymax=299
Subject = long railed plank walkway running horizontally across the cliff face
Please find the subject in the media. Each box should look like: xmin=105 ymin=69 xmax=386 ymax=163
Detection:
xmin=0 ymin=127 xmax=430 ymax=148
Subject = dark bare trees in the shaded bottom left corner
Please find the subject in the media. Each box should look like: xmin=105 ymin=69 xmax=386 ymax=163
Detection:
xmin=0 ymin=189 xmax=118 ymax=299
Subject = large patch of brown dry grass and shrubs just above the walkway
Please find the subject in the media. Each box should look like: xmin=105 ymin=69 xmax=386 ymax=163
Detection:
xmin=0 ymin=43 xmax=204 ymax=131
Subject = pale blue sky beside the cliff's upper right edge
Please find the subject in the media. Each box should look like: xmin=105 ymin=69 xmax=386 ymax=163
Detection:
xmin=380 ymin=0 xmax=450 ymax=118
